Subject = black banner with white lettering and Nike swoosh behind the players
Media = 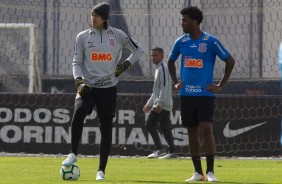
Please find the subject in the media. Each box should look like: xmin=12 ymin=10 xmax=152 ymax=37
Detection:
xmin=0 ymin=94 xmax=282 ymax=157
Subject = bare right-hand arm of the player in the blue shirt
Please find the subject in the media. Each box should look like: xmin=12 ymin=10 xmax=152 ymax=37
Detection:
xmin=206 ymin=55 xmax=235 ymax=93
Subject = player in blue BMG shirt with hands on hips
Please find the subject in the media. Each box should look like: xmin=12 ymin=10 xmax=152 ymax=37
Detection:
xmin=168 ymin=6 xmax=235 ymax=182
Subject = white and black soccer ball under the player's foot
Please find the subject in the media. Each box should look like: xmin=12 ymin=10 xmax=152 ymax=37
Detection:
xmin=60 ymin=164 xmax=80 ymax=180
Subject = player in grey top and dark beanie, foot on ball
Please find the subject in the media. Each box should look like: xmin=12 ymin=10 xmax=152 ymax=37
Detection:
xmin=62 ymin=2 xmax=144 ymax=180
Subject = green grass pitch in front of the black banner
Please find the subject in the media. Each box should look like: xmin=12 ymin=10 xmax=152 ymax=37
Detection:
xmin=0 ymin=156 xmax=282 ymax=184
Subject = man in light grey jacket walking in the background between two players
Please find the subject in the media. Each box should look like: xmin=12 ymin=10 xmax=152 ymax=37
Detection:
xmin=143 ymin=47 xmax=177 ymax=159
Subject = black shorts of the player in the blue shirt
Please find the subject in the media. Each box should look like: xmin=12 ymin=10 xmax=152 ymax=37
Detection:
xmin=180 ymin=96 xmax=215 ymax=127
